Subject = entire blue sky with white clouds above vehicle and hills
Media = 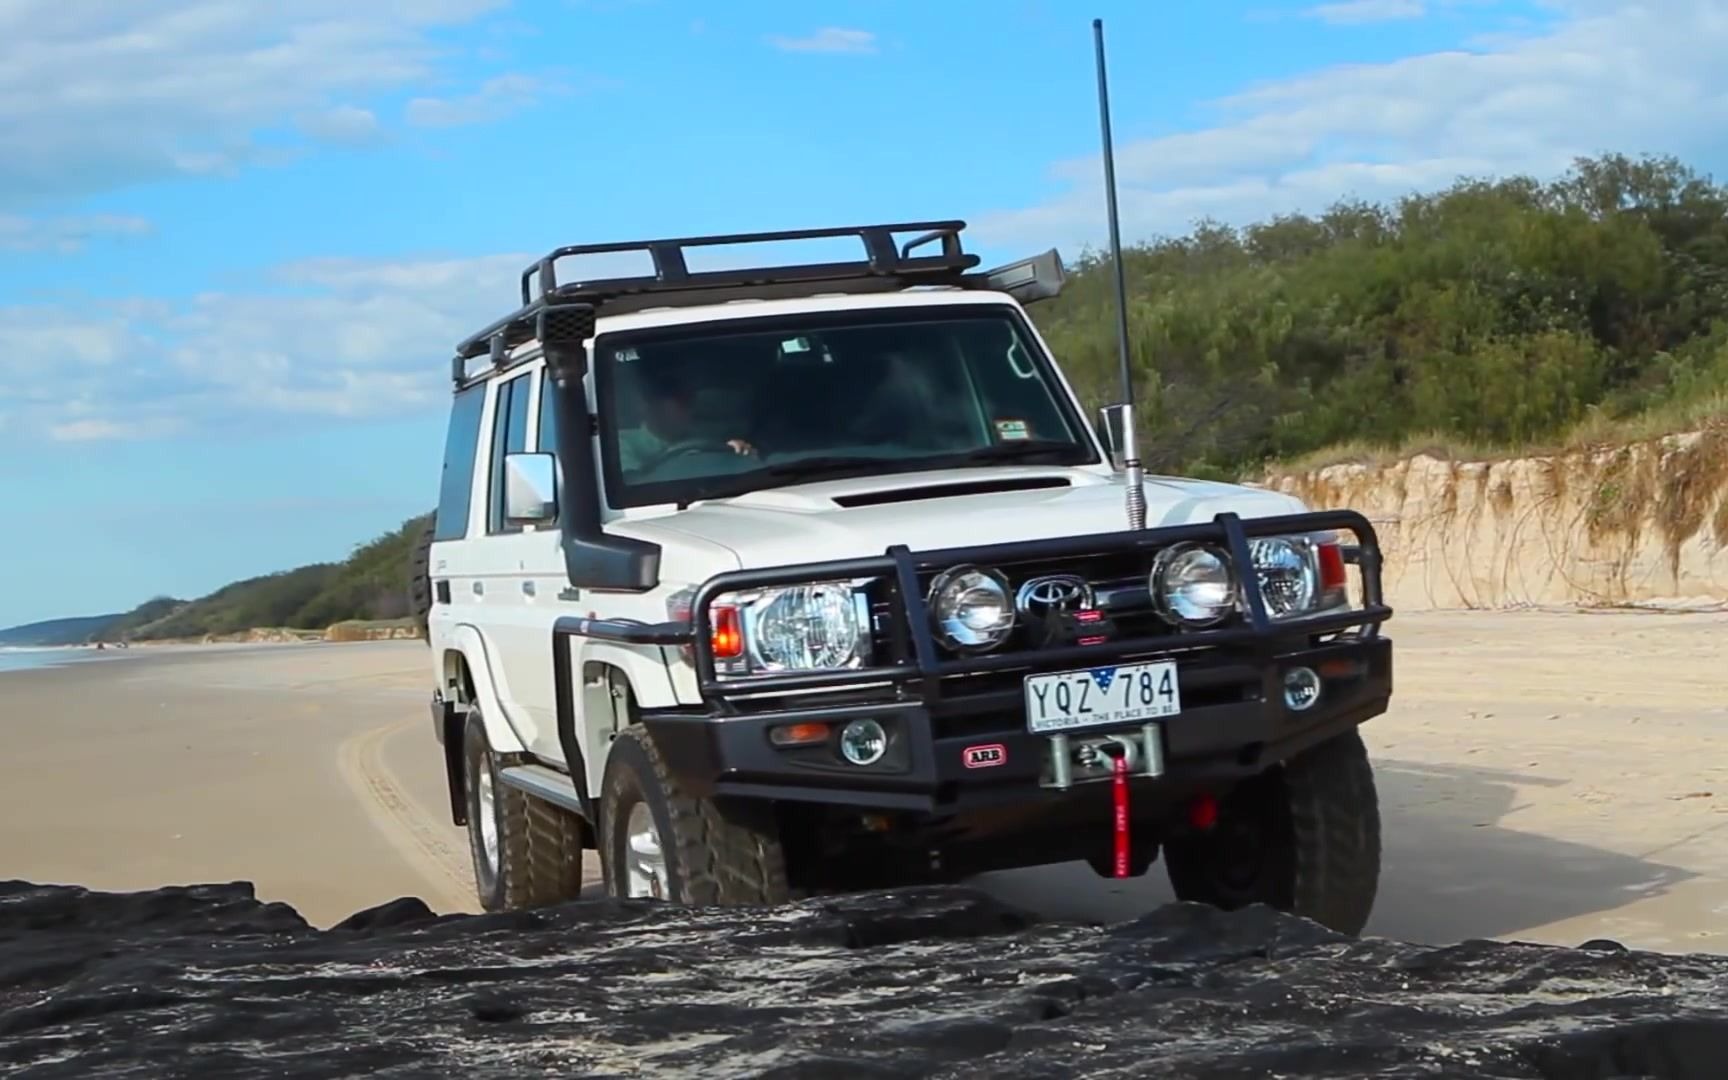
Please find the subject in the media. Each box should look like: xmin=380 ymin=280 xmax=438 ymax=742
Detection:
xmin=0 ymin=0 xmax=1728 ymax=626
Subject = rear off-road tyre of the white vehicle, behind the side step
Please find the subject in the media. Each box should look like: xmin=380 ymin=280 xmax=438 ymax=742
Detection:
xmin=463 ymin=707 xmax=582 ymax=911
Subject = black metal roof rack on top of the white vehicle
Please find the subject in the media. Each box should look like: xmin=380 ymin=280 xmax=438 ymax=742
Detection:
xmin=453 ymin=221 xmax=1063 ymax=373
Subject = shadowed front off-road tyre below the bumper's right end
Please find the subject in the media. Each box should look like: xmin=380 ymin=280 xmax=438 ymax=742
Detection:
xmin=1163 ymin=729 xmax=1381 ymax=935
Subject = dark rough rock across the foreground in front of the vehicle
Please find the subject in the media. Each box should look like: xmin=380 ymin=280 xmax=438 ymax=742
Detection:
xmin=0 ymin=883 xmax=1728 ymax=1080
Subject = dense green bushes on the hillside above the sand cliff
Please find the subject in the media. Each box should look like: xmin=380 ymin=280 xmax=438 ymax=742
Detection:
xmin=1037 ymin=156 xmax=1728 ymax=477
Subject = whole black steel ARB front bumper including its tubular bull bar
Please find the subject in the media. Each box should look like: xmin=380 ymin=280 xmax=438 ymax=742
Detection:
xmin=608 ymin=511 xmax=1391 ymax=814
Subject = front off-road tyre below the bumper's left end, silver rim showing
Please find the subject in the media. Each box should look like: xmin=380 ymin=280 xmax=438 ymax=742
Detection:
xmin=598 ymin=726 xmax=791 ymax=907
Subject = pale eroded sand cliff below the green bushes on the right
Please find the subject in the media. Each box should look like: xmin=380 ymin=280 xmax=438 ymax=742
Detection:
xmin=1265 ymin=429 xmax=1728 ymax=608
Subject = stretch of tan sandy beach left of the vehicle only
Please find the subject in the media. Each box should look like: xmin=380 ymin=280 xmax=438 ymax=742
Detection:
xmin=0 ymin=641 xmax=494 ymax=924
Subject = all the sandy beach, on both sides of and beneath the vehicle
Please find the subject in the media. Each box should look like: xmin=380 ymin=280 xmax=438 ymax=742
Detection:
xmin=0 ymin=612 xmax=1728 ymax=952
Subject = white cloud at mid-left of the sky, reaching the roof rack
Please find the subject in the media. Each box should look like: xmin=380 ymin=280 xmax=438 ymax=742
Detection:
xmin=0 ymin=254 xmax=641 ymax=441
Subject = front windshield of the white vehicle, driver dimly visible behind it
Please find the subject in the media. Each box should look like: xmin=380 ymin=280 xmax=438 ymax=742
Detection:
xmin=594 ymin=304 xmax=1097 ymax=506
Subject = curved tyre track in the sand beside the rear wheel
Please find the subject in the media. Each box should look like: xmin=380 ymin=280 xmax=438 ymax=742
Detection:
xmin=337 ymin=717 xmax=475 ymax=911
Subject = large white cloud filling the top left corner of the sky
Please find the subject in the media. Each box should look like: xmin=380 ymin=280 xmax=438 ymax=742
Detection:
xmin=0 ymin=0 xmax=525 ymax=206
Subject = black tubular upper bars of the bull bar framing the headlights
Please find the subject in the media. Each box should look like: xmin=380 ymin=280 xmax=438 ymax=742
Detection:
xmin=653 ymin=510 xmax=1393 ymax=710
